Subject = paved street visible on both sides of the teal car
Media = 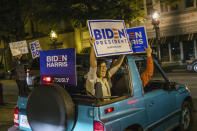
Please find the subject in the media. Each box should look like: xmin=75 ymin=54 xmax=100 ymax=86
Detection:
xmin=0 ymin=72 xmax=197 ymax=131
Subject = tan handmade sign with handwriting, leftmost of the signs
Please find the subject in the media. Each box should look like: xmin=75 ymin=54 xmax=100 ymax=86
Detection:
xmin=9 ymin=40 xmax=29 ymax=56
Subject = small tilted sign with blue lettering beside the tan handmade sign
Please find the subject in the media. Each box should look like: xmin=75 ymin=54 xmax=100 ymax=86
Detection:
xmin=29 ymin=40 xmax=41 ymax=59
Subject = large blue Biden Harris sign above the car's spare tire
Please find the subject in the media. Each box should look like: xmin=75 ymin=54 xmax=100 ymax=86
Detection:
xmin=40 ymin=48 xmax=76 ymax=86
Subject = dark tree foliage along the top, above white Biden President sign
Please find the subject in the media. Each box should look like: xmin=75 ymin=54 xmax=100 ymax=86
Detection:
xmin=26 ymin=0 xmax=144 ymax=27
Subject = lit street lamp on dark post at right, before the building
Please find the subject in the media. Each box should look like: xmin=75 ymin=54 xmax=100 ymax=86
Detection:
xmin=152 ymin=11 xmax=161 ymax=62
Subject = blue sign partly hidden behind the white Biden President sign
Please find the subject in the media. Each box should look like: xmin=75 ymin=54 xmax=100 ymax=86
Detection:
xmin=127 ymin=27 xmax=148 ymax=53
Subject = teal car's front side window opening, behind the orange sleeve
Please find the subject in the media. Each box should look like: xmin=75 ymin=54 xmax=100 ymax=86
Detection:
xmin=136 ymin=59 xmax=167 ymax=93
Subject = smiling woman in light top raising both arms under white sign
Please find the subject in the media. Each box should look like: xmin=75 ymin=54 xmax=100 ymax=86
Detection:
xmin=86 ymin=38 xmax=125 ymax=97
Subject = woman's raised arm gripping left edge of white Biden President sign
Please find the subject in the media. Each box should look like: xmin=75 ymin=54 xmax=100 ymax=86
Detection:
xmin=90 ymin=38 xmax=97 ymax=69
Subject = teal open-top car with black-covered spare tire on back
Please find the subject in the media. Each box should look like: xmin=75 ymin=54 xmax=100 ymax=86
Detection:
xmin=9 ymin=55 xmax=193 ymax=131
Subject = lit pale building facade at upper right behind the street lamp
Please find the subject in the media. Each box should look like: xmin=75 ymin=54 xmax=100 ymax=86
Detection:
xmin=144 ymin=0 xmax=197 ymax=62
